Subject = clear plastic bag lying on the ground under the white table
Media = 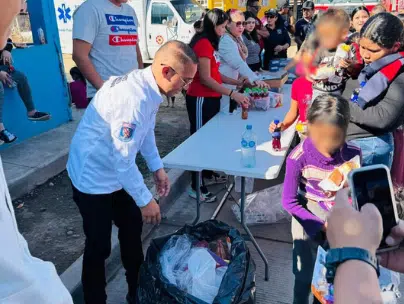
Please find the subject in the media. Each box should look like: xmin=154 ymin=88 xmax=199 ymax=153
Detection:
xmin=231 ymin=184 xmax=291 ymax=226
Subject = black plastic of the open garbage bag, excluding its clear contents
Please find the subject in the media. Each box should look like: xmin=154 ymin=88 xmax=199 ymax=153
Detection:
xmin=137 ymin=220 xmax=255 ymax=304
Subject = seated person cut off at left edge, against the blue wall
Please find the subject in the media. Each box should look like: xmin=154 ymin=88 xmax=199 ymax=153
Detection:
xmin=0 ymin=39 xmax=50 ymax=144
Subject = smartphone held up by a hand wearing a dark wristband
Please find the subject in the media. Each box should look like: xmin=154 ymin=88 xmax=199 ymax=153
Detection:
xmin=348 ymin=165 xmax=398 ymax=252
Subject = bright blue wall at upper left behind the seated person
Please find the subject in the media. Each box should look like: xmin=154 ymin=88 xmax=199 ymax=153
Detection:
xmin=0 ymin=0 xmax=71 ymax=150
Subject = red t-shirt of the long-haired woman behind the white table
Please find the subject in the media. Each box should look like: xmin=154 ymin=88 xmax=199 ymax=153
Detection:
xmin=187 ymin=38 xmax=222 ymax=97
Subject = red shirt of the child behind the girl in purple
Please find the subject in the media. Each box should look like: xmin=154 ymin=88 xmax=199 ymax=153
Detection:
xmin=292 ymin=77 xmax=313 ymax=122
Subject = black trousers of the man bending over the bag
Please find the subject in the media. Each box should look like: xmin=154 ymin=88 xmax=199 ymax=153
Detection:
xmin=73 ymin=186 xmax=144 ymax=304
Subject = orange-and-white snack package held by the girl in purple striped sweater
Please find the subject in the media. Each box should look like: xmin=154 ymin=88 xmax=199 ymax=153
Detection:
xmin=318 ymin=155 xmax=361 ymax=192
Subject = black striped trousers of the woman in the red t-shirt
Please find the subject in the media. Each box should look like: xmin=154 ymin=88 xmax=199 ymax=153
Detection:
xmin=185 ymin=95 xmax=221 ymax=190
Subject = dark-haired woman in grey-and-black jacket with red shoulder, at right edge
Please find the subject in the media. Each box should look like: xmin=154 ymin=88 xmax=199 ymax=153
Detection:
xmin=344 ymin=13 xmax=404 ymax=167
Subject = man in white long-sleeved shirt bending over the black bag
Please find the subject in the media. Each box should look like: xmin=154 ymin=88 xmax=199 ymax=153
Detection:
xmin=67 ymin=41 xmax=197 ymax=304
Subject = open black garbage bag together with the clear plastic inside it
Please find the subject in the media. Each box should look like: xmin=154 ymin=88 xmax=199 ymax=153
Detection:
xmin=137 ymin=220 xmax=255 ymax=304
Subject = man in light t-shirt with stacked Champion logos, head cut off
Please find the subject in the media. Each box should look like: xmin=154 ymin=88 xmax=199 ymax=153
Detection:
xmin=73 ymin=0 xmax=143 ymax=100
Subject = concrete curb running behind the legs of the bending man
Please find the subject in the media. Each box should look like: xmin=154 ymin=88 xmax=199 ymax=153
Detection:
xmin=60 ymin=169 xmax=189 ymax=300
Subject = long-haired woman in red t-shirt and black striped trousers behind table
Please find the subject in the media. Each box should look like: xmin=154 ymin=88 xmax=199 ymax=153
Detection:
xmin=186 ymin=9 xmax=249 ymax=203
